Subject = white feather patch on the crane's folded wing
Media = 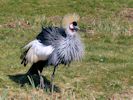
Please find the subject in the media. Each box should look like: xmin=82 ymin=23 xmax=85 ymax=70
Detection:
xmin=24 ymin=40 xmax=54 ymax=63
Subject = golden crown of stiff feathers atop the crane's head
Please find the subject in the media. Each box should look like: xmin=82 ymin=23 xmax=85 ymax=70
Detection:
xmin=62 ymin=13 xmax=80 ymax=29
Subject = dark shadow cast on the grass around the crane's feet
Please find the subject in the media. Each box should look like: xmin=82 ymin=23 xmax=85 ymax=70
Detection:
xmin=8 ymin=74 xmax=60 ymax=92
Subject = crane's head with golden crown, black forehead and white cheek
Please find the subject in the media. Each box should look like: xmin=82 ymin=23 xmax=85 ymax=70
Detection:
xmin=62 ymin=13 xmax=79 ymax=35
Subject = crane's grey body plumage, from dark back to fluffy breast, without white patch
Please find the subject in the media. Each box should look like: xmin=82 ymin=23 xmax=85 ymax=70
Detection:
xmin=37 ymin=27 xmax=84 ymax=66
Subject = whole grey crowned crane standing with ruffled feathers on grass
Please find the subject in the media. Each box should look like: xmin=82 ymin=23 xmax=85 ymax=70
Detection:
xmin=21 ymin=14 xmax=84 ymax=88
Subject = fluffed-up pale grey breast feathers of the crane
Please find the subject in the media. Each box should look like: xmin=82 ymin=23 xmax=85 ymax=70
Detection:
xmin=49 ymin=36 xmax=84 ymax=66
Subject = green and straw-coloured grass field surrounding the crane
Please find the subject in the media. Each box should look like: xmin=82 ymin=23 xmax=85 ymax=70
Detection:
xmin=0 ymin=0 xmax=133 ymax=100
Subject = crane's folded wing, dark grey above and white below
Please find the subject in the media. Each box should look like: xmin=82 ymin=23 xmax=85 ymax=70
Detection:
xmin=21 ymin=27 xmax=65 ymax=66
